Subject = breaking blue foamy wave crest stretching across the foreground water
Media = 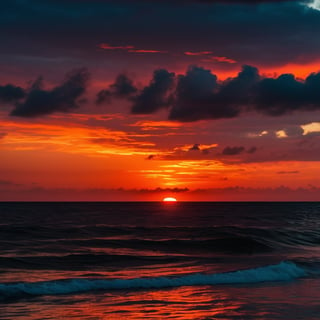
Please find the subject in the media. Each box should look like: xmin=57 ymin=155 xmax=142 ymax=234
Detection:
xmin=0 ymin=261 xmax=308 ymax=299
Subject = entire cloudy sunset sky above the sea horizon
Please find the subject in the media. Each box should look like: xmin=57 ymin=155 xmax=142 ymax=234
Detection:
xmin=0 ymin=0 xmax=320 ymax=201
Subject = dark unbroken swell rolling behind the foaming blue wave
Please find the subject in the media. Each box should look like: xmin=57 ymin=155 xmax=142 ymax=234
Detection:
xmin=0 ymin=226 xmax=320 ymax=253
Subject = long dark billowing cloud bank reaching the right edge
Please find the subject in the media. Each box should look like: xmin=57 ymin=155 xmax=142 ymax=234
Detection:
xmin=124 ymin=66 xmax=320 ymax=121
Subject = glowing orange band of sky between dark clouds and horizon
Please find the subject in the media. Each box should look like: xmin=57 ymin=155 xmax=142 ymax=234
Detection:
xmin=1 ymin=95 xmax=320 ymax=201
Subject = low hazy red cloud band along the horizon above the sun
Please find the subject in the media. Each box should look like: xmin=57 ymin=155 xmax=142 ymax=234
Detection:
xmin=0 ymin=183 xmax=320 ymax=201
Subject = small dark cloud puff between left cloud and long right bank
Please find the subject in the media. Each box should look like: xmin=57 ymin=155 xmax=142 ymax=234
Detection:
xmin=96 ymin=74 xmax=137 ymax=104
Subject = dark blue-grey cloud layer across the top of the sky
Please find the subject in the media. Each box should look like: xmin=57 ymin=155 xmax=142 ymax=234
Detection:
xmin=0 ymin=0 xmax=320 ymax=69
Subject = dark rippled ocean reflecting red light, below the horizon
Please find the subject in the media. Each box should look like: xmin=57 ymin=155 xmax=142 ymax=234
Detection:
xmin=0 ymin=202 xmax=320 ymax=320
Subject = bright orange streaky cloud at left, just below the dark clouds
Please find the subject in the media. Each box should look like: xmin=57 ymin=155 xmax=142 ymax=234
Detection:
xmin=0 ymin=117 xmax=159 ymax=156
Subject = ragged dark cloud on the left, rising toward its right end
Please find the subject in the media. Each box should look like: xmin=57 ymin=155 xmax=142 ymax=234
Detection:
xmin=11 ymin=68 xmax=89 ymax=117
